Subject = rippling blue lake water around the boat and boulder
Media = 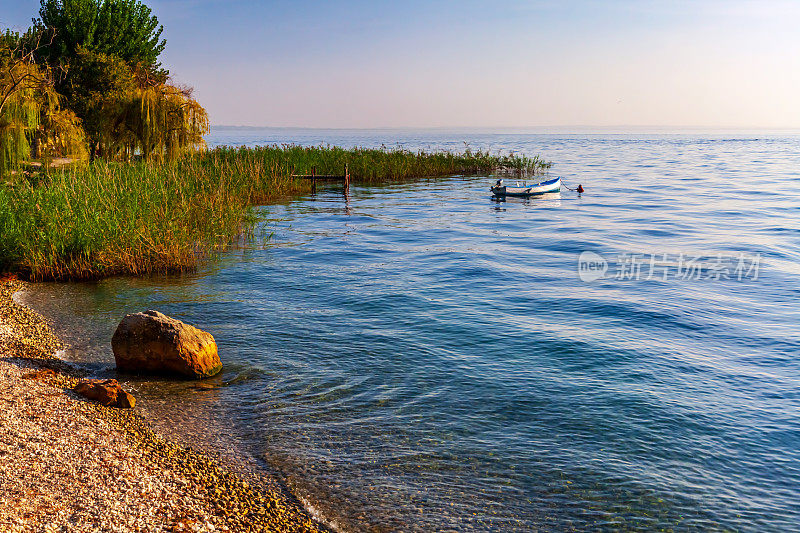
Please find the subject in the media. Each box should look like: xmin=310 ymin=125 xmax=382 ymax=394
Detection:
xmin=23 ymin=129 xmax=800 ymax=532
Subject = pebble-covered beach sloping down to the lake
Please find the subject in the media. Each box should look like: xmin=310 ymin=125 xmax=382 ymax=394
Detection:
xmin=0 ymin=281 xmax=322 ymax=532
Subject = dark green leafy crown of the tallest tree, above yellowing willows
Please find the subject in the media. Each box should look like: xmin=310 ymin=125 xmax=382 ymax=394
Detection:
xmin=36 ymin=0 xmax=166 ymax=70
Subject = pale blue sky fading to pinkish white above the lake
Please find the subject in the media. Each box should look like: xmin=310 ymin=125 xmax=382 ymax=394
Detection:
xmin=0 ymin=0 xmax=800 ymax=129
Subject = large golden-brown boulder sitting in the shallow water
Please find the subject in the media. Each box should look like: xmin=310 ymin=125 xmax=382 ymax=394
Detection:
xmin=111 ymin=311 xmax=222 ymax=379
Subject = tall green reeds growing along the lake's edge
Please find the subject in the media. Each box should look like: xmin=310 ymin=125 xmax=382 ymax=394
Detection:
xmin=0 ymin=145 xmax=548 ymax=280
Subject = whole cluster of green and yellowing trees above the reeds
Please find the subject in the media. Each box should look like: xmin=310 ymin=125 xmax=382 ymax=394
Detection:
xmin=0 ymin=0 xmax=209 ymax=173
